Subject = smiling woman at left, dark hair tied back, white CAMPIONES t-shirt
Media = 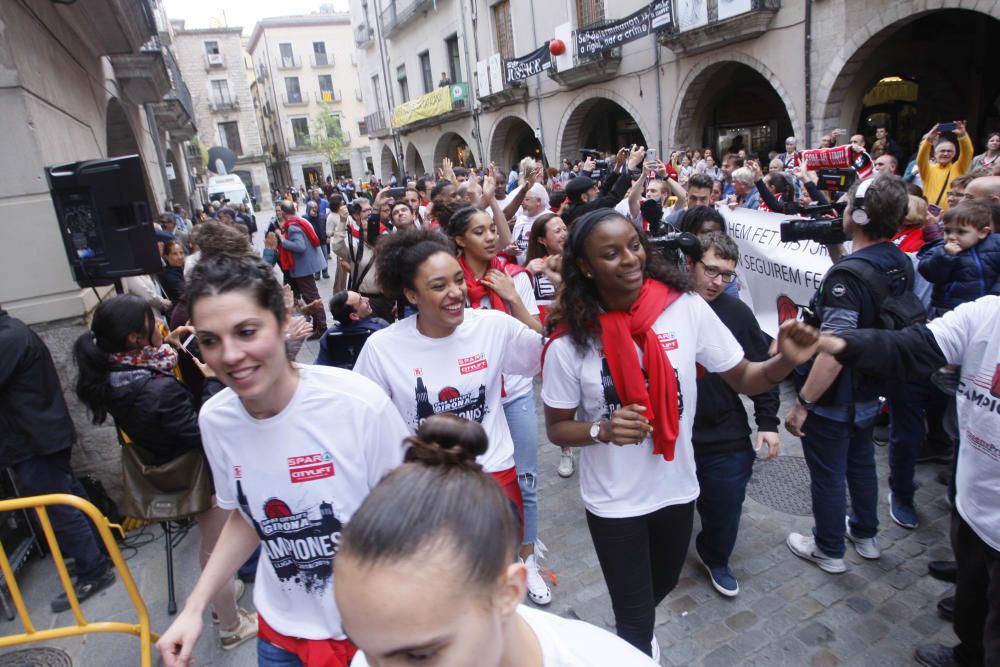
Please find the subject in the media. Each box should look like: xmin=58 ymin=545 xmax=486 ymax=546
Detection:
xmin=157 ymin=255 xmax=408 ymax=667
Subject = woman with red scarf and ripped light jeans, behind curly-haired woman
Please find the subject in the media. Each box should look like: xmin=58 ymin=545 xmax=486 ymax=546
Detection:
xmin=445 ymin=206 xmax=552 ymax=605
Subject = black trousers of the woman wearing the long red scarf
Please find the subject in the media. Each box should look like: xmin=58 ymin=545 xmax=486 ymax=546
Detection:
xmin=587 ymin=501 xmax=694 ymax=655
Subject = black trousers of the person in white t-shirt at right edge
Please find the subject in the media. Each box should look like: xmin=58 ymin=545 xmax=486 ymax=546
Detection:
xmin=951 ymin=512 xmax=1000 ymax=667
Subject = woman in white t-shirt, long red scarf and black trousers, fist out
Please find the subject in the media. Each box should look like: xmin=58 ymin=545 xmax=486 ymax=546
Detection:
xmin=542 ymin=209 xmax=817 ymax=655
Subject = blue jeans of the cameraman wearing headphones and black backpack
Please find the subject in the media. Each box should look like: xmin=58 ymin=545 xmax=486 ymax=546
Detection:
xmin=802 ymin=413 xmax=878 ymax=558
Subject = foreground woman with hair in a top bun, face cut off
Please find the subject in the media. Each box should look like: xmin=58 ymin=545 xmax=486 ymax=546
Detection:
xmin=336 ymin=415 xmax=655 ymax=667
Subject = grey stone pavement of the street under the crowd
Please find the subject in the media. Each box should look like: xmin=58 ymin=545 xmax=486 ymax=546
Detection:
xmin=0 ymin=310 xmax=955 ymax=667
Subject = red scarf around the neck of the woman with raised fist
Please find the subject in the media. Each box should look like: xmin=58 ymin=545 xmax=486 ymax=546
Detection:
xmin=542 ymin=278 xmax=681 ymax=461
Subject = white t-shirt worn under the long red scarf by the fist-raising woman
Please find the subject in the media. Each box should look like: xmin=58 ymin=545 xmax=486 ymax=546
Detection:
xmin=542 ymin=293 xmax=743 ymax=519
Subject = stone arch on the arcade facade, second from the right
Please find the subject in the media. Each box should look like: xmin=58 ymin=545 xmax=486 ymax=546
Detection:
xmin=668 ymin=51 xmax=805 ymax=153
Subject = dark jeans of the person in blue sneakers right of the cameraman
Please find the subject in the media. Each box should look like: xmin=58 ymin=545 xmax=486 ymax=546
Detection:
xmin=889 ymin=382 xmax=948 ymax=504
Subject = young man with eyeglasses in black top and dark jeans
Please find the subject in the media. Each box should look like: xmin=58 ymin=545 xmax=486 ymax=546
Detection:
xmin=691 ymin=233 xmax=780 ymax=597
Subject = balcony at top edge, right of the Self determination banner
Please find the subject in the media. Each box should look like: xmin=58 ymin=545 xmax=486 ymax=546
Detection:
xmin=656 ymin=0 xmax=781 ymax=56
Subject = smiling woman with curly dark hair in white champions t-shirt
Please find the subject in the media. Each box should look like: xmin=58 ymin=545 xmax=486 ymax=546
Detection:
xmin=354 ymin=229 xmax=542 ymax=532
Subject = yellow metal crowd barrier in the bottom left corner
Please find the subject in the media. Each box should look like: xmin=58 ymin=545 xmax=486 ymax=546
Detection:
xmin=0 ymin=493 xmax=159 ymax=667
